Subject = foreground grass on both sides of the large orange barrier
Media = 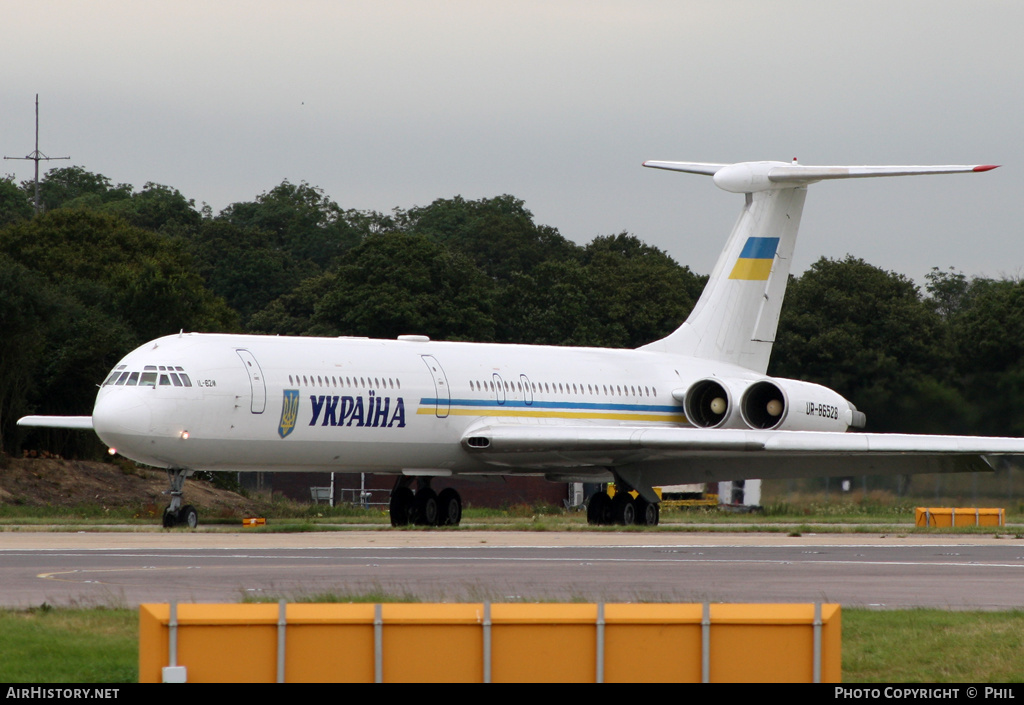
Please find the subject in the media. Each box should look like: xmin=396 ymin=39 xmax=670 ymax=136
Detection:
xmin=0 ymin=591 xmax=1024 ymax=683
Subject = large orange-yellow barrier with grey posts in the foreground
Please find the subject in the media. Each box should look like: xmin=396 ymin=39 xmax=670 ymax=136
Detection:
xmin=138 ymin=602 xmax=841 ymax=682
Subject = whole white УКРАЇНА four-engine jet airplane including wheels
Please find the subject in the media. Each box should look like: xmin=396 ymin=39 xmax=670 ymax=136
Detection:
xmin=18 ymin=160 xmax=1024 ymax=528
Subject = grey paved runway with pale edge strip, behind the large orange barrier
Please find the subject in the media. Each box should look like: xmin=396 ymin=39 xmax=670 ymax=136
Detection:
xmin=0 ymin=531 xmax=1024 ymax=610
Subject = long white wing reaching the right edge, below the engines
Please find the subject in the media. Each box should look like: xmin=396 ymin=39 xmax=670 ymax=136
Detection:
xmin=462 ymin=423 xmax=1024 ymax=485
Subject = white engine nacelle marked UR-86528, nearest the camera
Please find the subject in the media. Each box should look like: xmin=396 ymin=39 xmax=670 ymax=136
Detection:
xmin=739 ymin=379 xmax=865 ymax=431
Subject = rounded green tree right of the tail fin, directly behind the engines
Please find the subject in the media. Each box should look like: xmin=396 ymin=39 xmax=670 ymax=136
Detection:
xmin=769 ymin=256 xmax=968 ymax=432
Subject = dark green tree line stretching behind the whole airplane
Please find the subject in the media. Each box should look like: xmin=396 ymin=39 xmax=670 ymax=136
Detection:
xmin=0 ymin=166 xmax=1024 ymax=456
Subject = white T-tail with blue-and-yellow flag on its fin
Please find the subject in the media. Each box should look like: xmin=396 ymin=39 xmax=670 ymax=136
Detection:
xmin=641 ymin=160 xmax=995 ymax=374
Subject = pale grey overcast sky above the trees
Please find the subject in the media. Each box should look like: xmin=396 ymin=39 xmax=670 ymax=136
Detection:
xmin=0 ymin=0 xmax=1024 ymax=284
